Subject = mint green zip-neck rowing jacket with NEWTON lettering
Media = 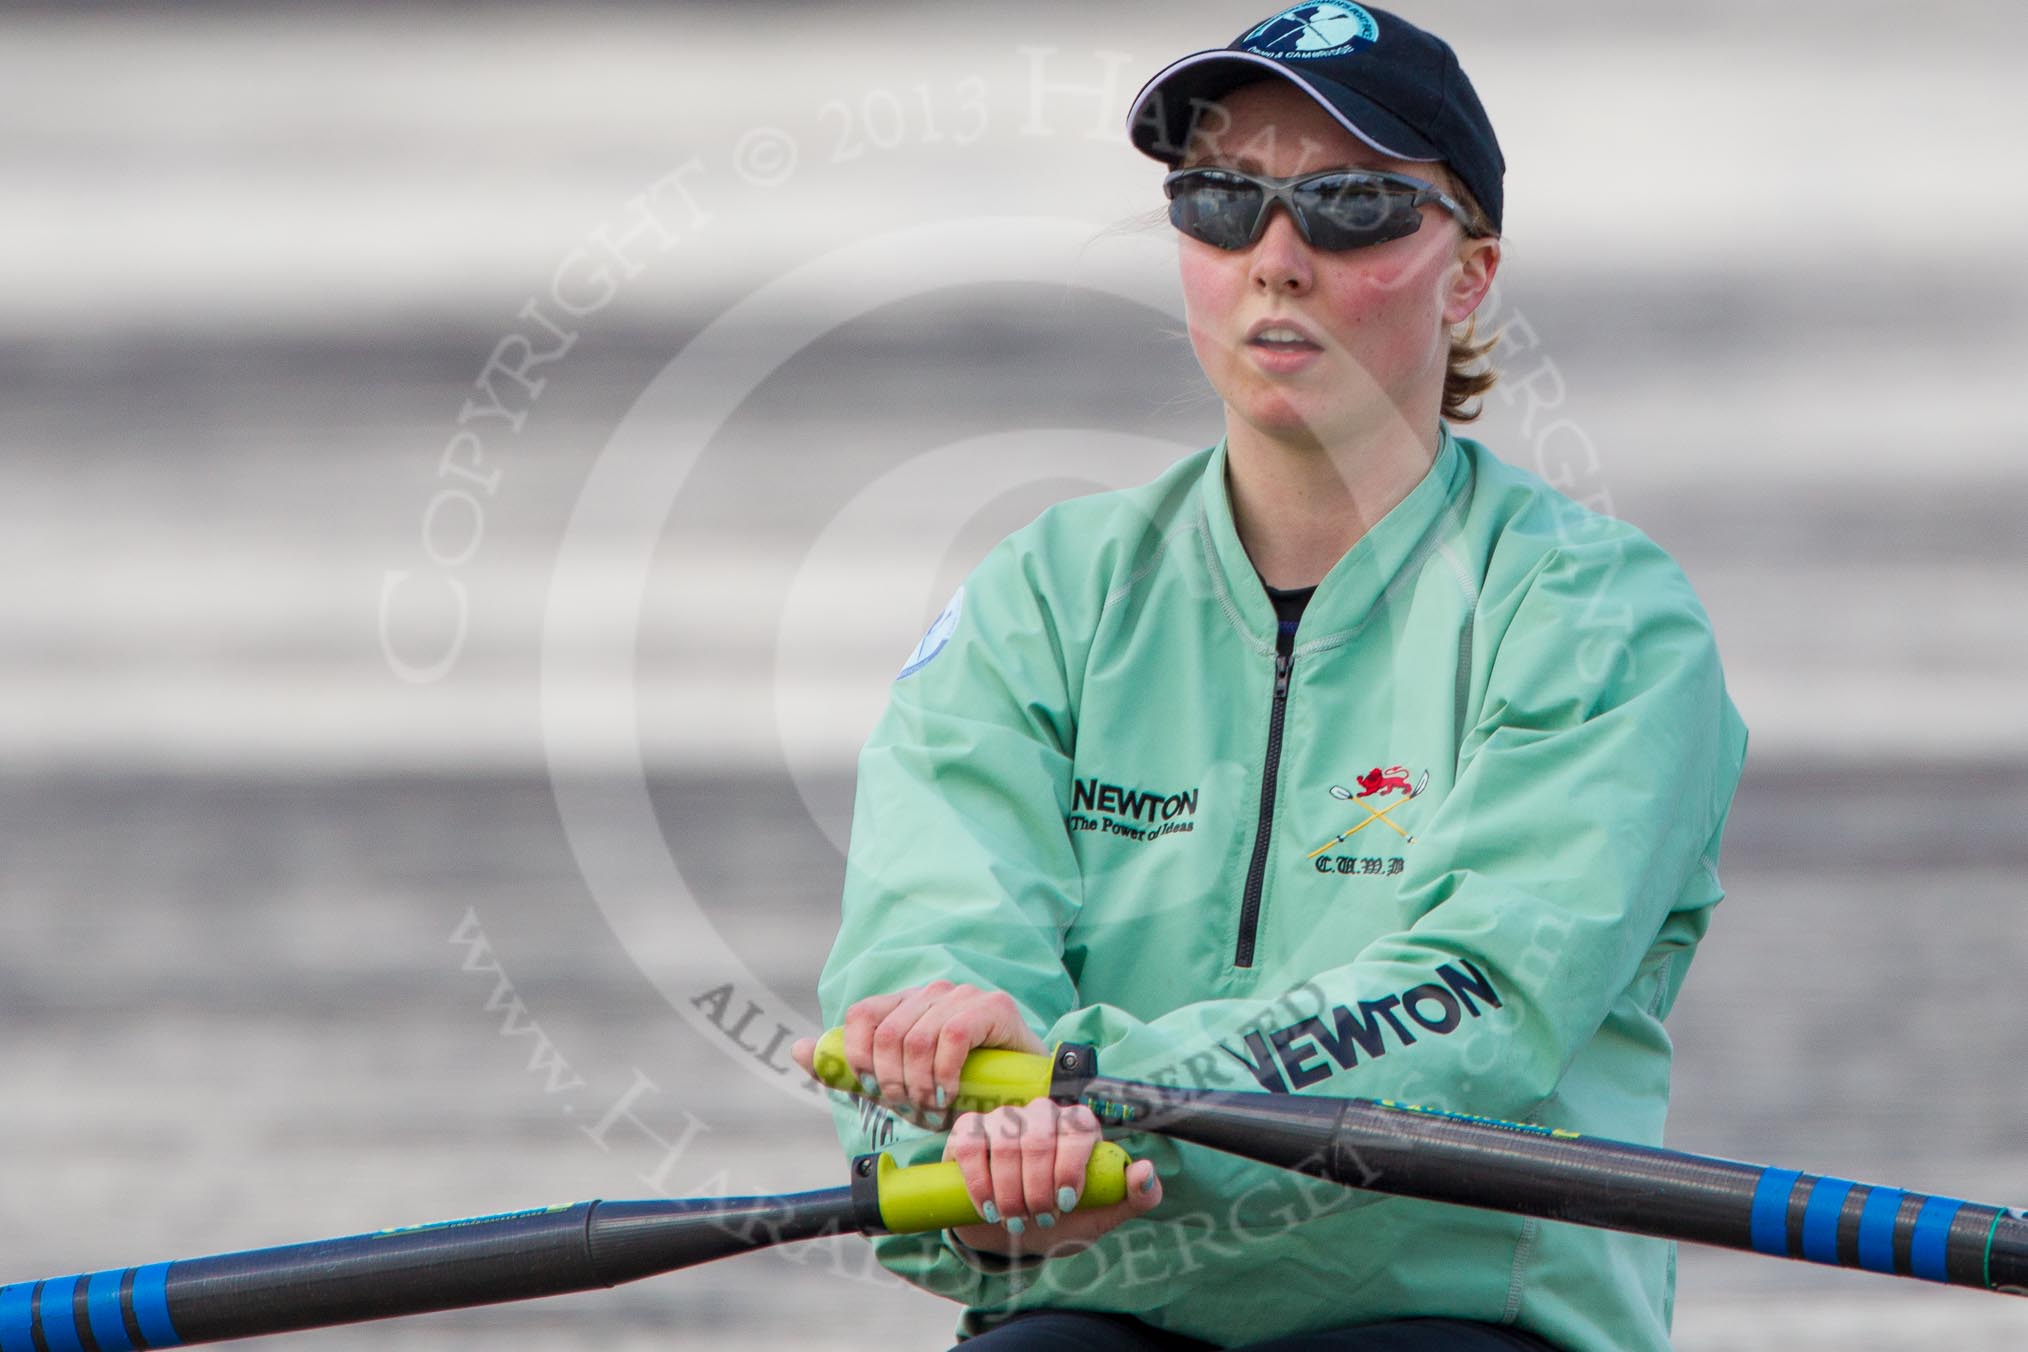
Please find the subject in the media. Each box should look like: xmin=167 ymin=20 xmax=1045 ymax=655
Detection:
xmin=819 ymin=430 xmax=1746 ymax=1352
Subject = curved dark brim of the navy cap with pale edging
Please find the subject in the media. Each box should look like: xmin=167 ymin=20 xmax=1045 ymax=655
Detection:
xmin=1128 ymin=49 xmax=1444 ymax=164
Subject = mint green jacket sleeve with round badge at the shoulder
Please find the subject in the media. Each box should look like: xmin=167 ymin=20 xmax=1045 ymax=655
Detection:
xmin=817 ymin=541 xmax=1081 ymax=1305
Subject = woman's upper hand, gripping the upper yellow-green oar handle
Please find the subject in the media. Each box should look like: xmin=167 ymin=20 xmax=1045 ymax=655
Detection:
xmin=789 ymin=981 xmax=1046 ymax=1127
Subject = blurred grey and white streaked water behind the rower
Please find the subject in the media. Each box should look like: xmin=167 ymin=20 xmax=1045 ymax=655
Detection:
xmin=0 ymin=0 xmax=2028 ymax=1350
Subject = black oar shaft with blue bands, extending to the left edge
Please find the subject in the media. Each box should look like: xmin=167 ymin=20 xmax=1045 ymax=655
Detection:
xmin=0 ymin=1188 xmax=862 ymax=1352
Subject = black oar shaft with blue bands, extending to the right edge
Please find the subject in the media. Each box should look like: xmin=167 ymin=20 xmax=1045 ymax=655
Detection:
xmin=1077 ymin=1078 xmax=2028 ymax=1295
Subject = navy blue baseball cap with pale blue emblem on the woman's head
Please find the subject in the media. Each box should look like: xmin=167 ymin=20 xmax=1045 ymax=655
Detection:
xmin=1128 ymin=4 xmax=1507 ymax=233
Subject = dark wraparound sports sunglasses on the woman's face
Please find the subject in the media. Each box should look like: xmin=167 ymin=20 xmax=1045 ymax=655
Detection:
xmin=1162 ymin=168 xmax=1482 ymax=253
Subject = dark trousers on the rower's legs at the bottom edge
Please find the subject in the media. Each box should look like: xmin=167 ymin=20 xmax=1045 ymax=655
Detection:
xmin=953 ymin=1309 xmax=1555 ymax=1352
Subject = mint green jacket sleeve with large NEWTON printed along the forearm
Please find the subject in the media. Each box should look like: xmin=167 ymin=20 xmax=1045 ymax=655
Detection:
xmin=1048 ymin=531 xmax=1746 ymax=1121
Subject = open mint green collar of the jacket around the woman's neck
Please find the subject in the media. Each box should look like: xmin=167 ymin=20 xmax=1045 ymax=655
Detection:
xmin=1197 ymin=424 xmax=1470 ymax=655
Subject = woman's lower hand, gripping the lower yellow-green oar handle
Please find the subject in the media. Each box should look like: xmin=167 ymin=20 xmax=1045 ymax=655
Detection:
xmin=943 ymin=1099 xmax=1162 ymax=1259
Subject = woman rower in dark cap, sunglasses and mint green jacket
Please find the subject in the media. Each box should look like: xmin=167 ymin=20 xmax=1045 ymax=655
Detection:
xmin=799 ymin=4 xmax=1744 ymax=1352
